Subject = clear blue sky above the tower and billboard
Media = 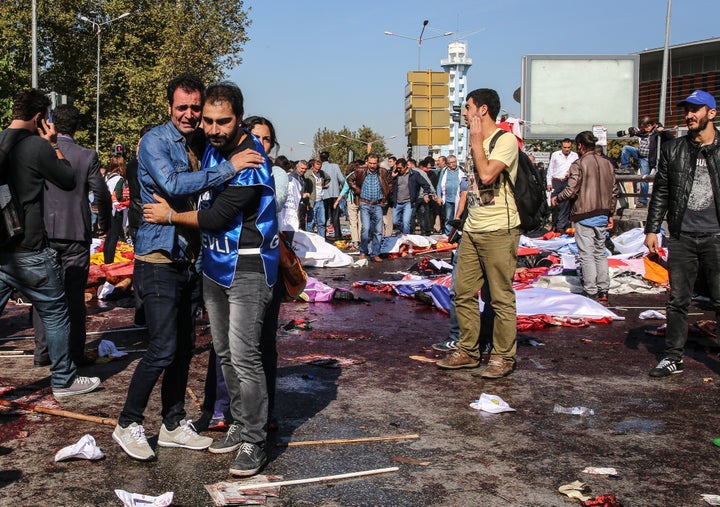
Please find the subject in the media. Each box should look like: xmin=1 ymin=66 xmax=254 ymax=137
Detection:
xmin=228 ymin=0 xmax=720 ymax=159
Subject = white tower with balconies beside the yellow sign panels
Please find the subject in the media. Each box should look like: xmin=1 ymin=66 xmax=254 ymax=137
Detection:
xmin=440 ymin=40 xmax=472 ymax=162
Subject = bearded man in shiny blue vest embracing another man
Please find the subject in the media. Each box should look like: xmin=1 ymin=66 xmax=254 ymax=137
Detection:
xmin=143 ymin=82 xmax=279 ymax=476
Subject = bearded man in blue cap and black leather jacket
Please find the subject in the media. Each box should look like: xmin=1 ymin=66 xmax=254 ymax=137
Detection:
xmin=645 ymin=90 xmax=720 ymax=377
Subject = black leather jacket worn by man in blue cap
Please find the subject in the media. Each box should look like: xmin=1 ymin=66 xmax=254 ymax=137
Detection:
xmin=645 ymin=129 xmax=720 ymax=238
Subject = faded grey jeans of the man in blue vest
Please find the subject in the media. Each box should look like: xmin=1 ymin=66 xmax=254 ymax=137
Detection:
xmin=203 ymin=274 xmax=272 ymax=444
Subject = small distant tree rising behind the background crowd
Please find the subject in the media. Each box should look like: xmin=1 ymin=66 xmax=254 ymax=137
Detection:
xmin=313 ymin=125 xmax=388 ymax=172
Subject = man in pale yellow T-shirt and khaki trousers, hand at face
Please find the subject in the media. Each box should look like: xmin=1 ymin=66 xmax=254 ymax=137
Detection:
xmin=437 ymin=88 xmax=520 ymax=379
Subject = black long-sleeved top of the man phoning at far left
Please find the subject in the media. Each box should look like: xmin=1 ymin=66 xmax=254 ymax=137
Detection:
xmin=2 ymin=129 xmax=75 ymax=251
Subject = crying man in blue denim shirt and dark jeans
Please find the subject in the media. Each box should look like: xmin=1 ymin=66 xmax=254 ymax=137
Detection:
xmin=113 ymin=74 xmax=264 ymax=460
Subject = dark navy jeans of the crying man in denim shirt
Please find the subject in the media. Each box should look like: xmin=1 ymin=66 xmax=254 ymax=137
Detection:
xmin=118 ymin=259 xmax=200 ymax=431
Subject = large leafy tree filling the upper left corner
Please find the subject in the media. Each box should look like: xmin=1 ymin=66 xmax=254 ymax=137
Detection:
xmin=0 ymin=0 xmax=250 ymax=162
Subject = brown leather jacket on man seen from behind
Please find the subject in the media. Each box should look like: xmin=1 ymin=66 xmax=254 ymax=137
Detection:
xmin=557 ymin=151 xmax=617 ymax=222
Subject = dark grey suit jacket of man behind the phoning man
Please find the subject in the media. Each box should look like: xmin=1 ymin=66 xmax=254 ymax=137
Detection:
xmin=44 ymin=136 xmax=111 ymax=243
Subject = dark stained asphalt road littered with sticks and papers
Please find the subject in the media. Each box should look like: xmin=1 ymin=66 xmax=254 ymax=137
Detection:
xmin=0 ymin=252 xmax=720 ymax=507
